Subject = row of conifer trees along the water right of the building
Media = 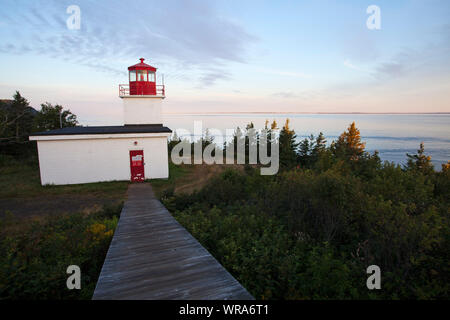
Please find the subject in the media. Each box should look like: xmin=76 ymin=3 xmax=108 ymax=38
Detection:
xmin=168 ymin=119 xmax=450 ymax=173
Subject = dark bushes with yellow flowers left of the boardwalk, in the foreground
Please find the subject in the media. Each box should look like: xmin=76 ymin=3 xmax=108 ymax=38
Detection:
xmin=0 ymin=206 xmax=121 ymax=299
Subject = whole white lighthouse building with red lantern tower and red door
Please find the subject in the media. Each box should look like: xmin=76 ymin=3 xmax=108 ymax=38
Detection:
xmin=30 ymin=58 xmax=172 ymax=185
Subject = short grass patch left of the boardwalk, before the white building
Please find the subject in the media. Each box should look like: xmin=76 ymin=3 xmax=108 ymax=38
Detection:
xmin=0 ymin=156 xmax=129 ymax=219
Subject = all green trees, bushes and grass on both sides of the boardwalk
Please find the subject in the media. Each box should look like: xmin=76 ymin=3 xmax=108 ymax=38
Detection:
xmin=0 ymin=93 xmax=450 ymax=299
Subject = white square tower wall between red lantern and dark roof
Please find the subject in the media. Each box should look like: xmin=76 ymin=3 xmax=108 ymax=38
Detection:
xmin=122 ymin=96 xmax=163 ymax=124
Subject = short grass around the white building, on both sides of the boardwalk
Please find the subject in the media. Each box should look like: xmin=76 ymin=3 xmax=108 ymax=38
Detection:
xmin=0 ymin=155 xmax=218 ymax=218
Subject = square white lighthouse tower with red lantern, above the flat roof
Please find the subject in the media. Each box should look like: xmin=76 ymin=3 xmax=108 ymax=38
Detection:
xmin=119 ymin=58 xmax=165 ymax=125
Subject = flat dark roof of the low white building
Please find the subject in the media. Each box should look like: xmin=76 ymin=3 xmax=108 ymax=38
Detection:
xmin=30 ymin=124 xmax=172 ymax=136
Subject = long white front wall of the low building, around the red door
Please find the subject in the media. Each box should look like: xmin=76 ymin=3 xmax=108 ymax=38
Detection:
xmin=32 ymin=134 xmax=169 ymax=185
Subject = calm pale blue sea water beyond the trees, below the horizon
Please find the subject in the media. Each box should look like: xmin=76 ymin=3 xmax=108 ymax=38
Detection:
xmin=164 ymin=114 xmax=450 ymax=170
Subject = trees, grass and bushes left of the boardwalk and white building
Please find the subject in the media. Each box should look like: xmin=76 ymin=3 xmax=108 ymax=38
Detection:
xmin=0 ymin=92 xmax=128 ymax=300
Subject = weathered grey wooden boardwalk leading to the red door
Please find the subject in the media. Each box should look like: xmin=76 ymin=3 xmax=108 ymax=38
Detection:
xmin=93 ymin=184 xmax=253 ymax=300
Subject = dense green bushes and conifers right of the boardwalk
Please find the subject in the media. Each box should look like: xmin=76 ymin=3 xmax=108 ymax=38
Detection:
xmin=162 ymin=122 xmax=450 ymax=299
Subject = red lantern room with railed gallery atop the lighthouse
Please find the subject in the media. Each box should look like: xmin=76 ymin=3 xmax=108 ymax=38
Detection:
xmin=119 ymin=58 xmax=165 ymax=97
